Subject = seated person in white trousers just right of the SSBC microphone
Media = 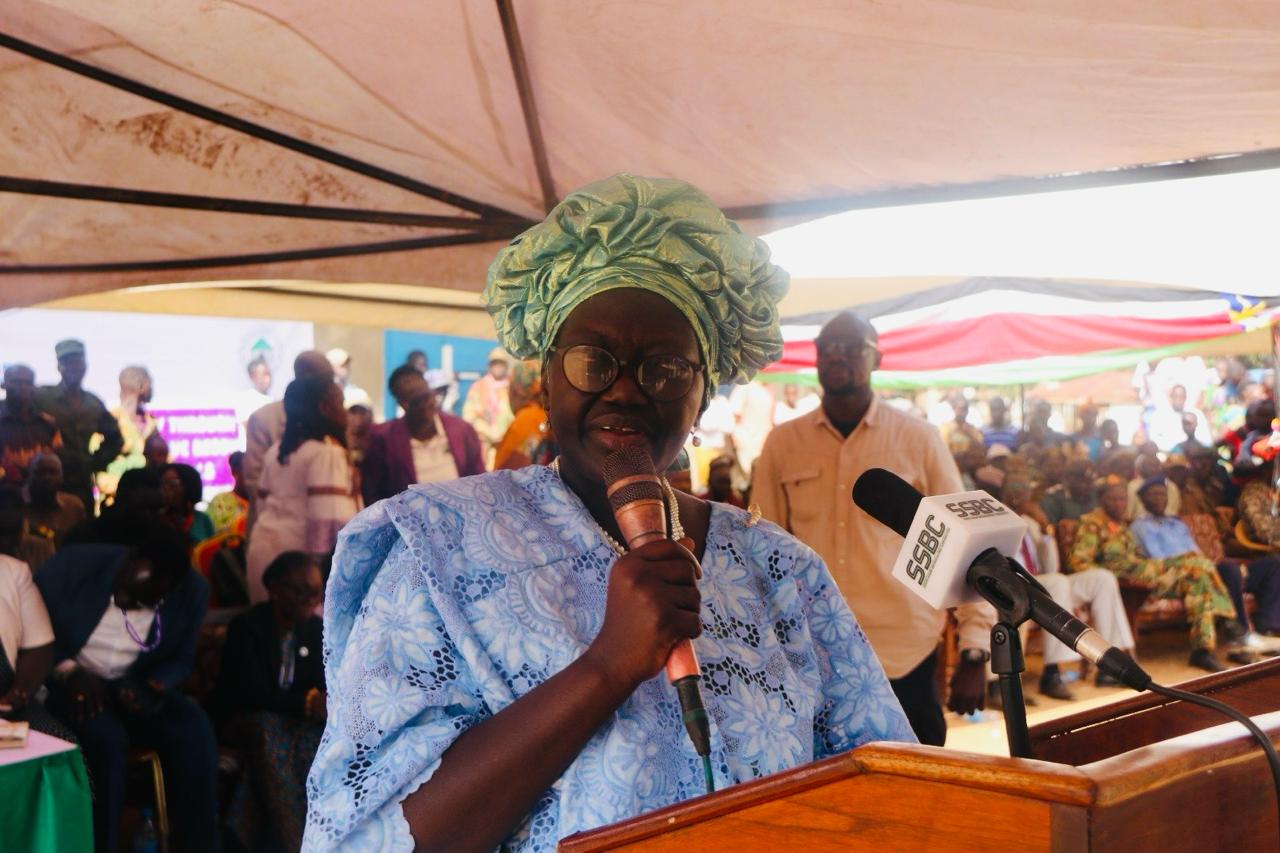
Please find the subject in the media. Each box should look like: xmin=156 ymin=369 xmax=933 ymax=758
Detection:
xmin=1001 ymin=478 xmax=1134 ymax=702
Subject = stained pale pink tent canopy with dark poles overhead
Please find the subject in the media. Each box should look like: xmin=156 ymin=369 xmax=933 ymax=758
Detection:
xmin=0 ymin=0 xmax=1280 ymax=313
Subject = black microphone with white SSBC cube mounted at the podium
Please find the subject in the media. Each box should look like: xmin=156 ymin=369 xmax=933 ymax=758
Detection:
xmin=854 ymin=467 xmax=1151 ymax=690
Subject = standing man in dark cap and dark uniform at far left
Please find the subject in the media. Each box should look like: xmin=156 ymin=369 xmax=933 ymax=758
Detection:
xmin=36 ymin=338 xmax=124 ymax=511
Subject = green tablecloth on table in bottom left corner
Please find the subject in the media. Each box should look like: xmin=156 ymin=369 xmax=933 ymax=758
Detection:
xmin=0 ymin=733 xmax=93 ymax=853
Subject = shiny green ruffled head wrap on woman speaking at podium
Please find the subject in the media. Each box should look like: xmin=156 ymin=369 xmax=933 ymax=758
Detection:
xmin=484 ymin=173 xmax=790 ymax=400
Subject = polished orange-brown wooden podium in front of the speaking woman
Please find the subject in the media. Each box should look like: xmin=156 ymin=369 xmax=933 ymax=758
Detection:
xmin=559 ymin=658 xmax=1280 ymax=853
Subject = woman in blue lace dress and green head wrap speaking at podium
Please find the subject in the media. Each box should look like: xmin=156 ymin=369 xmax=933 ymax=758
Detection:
xmin=305 ymin=174 xmax=914 ymax=850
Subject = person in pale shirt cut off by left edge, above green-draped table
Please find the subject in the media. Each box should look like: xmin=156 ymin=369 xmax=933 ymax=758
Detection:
xmin=0 ymin=555 xmax=76 ymax=740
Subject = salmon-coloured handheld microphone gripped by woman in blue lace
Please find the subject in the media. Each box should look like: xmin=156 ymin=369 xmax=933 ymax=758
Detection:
xmin=600 ymin=447 xmax=712 ymax=758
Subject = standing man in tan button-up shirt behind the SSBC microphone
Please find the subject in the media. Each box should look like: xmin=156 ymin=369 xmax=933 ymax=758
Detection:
xmin=751 ymin=313 xmax=995 ymax=745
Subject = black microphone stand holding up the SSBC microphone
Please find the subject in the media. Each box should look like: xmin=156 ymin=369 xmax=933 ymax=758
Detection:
xmin=965 ymin=548 xmax=1039 ymax=758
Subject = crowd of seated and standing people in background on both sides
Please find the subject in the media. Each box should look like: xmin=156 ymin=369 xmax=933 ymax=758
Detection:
xmin=0 ymin=330 xmax=1280 ymax=850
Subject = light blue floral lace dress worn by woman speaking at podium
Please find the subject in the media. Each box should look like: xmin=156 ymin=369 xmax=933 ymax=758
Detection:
xmin=303 ymin=465 xmax=915 ymax=850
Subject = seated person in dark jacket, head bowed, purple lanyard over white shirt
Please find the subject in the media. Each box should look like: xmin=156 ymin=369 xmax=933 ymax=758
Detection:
xmin=36 ymin=520 xmax=218 ymax=853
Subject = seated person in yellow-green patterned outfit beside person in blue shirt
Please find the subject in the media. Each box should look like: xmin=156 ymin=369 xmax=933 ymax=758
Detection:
xmin=1068 ymin=478 xmax=1239 ymax=672
